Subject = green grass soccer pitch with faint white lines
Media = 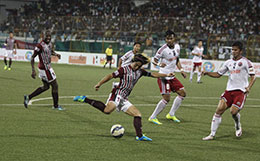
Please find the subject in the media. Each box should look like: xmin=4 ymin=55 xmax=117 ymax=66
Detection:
xmin=0 ymin=61 xmax=260 ymax=161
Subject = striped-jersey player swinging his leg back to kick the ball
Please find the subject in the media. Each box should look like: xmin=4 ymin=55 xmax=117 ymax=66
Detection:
xmin=74 ymin=54 xmax=174 ymax=141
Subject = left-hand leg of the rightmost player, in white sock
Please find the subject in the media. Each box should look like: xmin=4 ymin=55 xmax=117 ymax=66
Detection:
xmin=202 ymin=98 xmax=228 ymax=140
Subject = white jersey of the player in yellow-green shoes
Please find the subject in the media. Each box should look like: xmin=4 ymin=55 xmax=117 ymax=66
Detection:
xmin=154 ymin=44 xmax=180 ymax=80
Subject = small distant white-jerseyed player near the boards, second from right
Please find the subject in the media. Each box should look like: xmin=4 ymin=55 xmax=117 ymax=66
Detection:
xmin=190 ymin=40 xmax=204 ymax=83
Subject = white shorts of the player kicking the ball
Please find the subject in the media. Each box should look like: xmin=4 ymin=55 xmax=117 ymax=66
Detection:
xmin=106 ymin=93 xmax=132 ymax=112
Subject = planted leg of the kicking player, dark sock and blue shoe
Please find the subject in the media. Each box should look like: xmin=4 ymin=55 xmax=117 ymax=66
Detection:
xmin=125 ymin=105 xmax=152 ymax=141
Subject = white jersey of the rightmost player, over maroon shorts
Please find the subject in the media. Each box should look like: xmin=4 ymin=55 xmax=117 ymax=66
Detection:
xmin=218 ymin=57 xmax=255 ymax=92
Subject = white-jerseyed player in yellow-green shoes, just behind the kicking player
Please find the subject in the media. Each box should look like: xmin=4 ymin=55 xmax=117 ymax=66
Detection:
xmin=148 ymin=30 xmax=186 ymax=124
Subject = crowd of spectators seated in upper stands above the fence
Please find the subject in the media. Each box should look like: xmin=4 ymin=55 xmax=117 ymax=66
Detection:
xmin=0 ymin=0 xmax=260 ymax=44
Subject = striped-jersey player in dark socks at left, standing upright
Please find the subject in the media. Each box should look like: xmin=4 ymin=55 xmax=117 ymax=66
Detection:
xmin=24 ymin=31 xmax=64 ymax=110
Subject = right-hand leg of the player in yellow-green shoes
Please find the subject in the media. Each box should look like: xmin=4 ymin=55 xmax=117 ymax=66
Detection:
xmin=166 ymin=78 xmax=186 ymax=122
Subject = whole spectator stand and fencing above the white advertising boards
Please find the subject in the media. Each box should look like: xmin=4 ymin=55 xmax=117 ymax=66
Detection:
xmin=0 ymin=0 xmax=260 ymax=62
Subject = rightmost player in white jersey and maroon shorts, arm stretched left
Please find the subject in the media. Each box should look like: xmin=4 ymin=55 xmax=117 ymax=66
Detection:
xmin=202 ymin=41 xmax=256 ymax=140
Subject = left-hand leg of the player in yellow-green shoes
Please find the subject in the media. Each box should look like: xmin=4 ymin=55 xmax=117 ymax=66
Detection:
xmin=148 ymin=78 xmax=171 ymax=124
